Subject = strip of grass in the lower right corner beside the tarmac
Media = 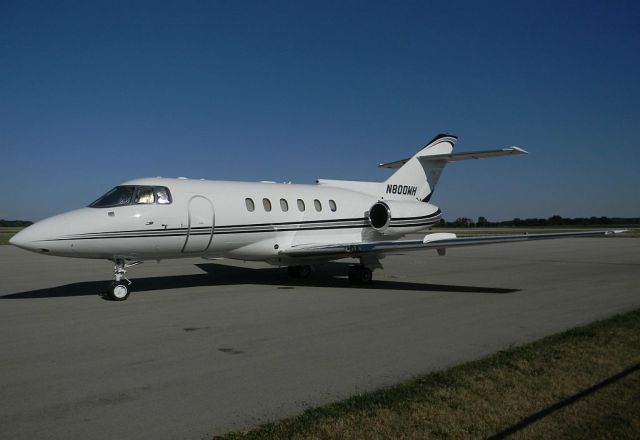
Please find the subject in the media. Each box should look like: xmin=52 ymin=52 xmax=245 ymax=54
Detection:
xmin=217 ymin=310 xmax=640 ymax=439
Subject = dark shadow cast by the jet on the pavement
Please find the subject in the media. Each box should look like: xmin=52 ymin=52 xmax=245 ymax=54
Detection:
xmin=0 ymin=263 xmax=520 ymax=299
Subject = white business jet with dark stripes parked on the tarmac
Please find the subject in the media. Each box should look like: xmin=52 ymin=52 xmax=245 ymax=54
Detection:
xmin=10 ymin=134 xmax=618 ymax=301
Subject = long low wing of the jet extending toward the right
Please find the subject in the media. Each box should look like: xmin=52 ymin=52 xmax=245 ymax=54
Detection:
xmin=280 ymin=230 xmax=626 ymax=260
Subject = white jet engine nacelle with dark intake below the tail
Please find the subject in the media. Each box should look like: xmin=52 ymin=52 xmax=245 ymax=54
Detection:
xmin=367 ymin=200 xmax=440 ymax=235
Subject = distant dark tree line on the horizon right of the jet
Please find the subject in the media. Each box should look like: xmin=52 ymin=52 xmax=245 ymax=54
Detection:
xmin=436 ymin=215 xmax=640 ymax=228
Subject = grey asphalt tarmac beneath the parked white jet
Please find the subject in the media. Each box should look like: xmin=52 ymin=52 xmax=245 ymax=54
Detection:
xmin=0 ymin=238 xmax=640 ymax=440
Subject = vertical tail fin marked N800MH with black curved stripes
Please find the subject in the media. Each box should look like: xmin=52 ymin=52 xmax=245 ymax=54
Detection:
xmin=380 ymin=134 xmax=458 ymax=202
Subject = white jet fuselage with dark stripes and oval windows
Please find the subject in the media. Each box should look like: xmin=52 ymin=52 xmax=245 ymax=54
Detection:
xmin=12 ymin=178 xmax=441 ymax=265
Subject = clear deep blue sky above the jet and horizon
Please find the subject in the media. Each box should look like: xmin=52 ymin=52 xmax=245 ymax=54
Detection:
xmin=0 ymin=0 xmax=640 ymax=220
